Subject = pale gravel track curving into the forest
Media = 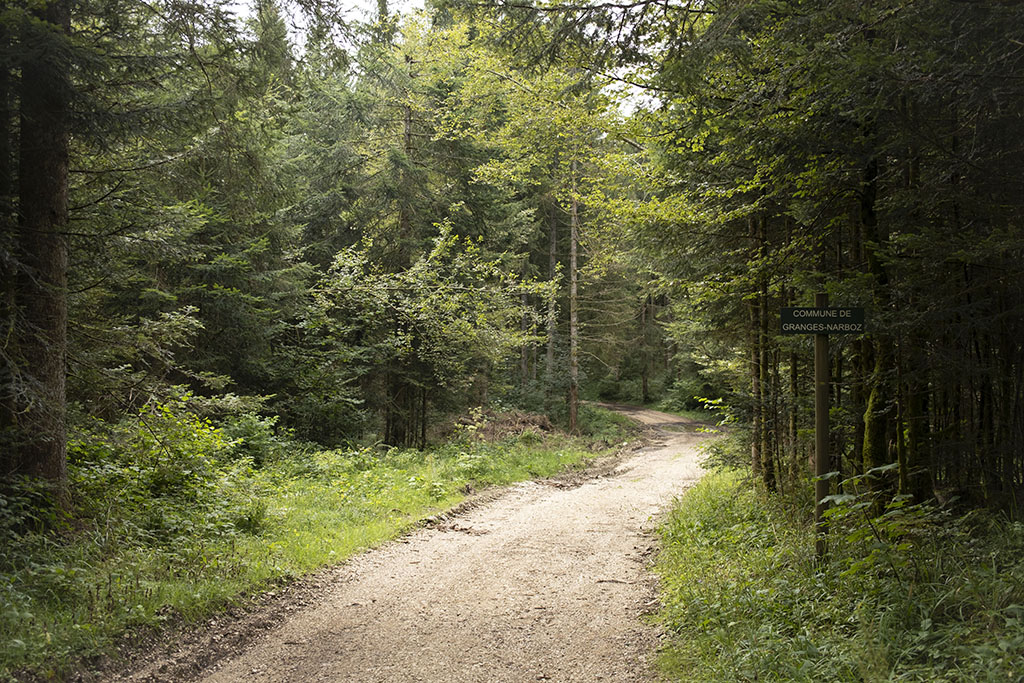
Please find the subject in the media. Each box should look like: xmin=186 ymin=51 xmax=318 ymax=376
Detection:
xmin=110 ymin=407 xmax=702 ymax=683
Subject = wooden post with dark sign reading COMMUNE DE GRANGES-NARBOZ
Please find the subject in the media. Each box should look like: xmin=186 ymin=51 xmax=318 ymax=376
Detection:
xmin=779 ymin=292 xmax=864 ymax=557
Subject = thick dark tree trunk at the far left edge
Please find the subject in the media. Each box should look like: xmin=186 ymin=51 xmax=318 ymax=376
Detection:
xmin=9 ymin=0 xmax=71 ymax=505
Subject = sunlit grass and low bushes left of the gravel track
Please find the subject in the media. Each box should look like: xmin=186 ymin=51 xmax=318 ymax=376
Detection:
xmin=0 ymin=407 xmax=623 ymax=680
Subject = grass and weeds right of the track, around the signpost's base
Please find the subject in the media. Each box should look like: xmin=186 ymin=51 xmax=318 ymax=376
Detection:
xmin=658 ymin=471 xmax=1024 ymax=683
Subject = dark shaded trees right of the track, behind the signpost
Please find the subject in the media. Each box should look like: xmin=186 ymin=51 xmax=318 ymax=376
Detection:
xmin=620 ymin=0 xmax=1024 ymax=510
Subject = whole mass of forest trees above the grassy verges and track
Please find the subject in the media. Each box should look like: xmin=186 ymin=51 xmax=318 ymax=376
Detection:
xmin=0 ymin=0 xmax=1024 ymax=528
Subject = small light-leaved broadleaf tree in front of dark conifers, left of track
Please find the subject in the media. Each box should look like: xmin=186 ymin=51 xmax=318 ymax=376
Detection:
xmin=303 ymin=225 xmax=542 ymax=445
